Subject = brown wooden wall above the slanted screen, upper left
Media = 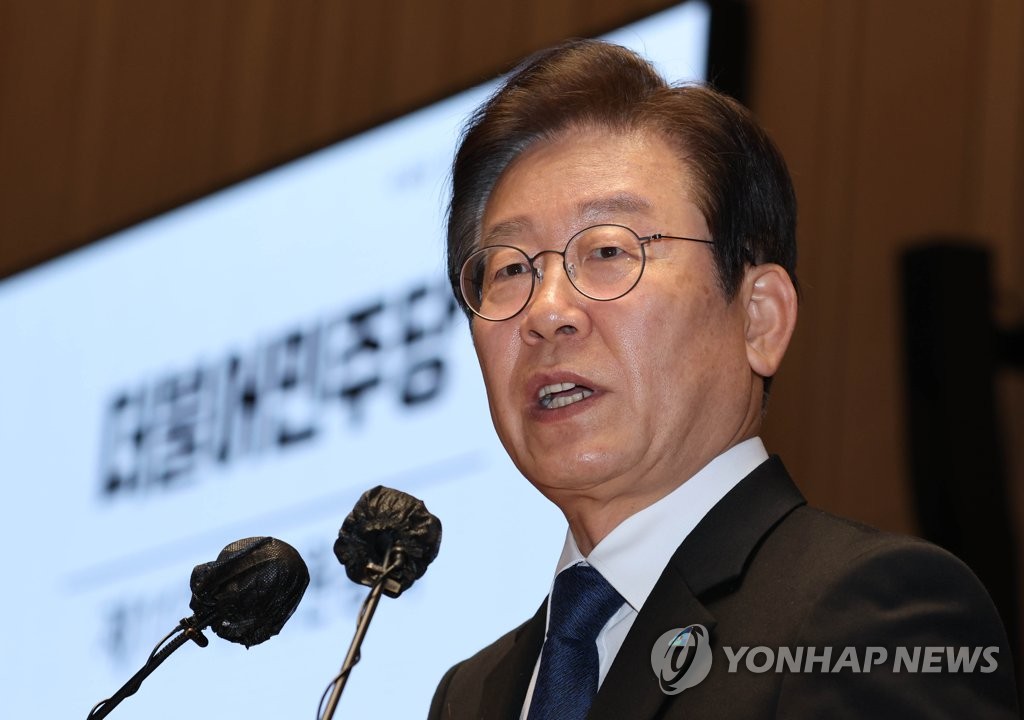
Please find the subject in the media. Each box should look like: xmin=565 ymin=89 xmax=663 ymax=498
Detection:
xmin=0 ymin=0 xmax=671 ymax=278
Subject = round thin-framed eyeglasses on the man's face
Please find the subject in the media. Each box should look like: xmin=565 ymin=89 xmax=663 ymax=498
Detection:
xmin=459 ymin=224 xmax=714 ymax=322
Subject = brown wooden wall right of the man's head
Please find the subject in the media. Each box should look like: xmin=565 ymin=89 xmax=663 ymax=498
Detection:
xmin=753 ymin=0 xmax=1024 ymax=530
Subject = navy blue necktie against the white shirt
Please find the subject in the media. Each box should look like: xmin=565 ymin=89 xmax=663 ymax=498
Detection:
xmin=527 ymin=564 xmax=625 ymax=720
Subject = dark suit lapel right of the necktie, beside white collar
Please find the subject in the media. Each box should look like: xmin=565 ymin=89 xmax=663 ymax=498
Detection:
xmin=589 ymin=456 xmax=806 ymax=720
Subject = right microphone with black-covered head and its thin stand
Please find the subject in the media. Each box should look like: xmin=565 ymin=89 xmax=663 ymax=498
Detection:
xmin=316 ymin=485 xmax=441 ymax=720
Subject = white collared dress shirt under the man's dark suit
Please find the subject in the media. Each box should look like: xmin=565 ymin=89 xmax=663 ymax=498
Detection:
xmin=520 ymin=437 xmax=768 ymax=720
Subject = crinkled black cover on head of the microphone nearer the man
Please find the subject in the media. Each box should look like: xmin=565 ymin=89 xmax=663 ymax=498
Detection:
xmin=334 ymin=485 xmax=441 ymax=597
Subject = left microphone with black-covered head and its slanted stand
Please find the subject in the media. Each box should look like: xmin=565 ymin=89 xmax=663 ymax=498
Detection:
xmin=87 ymin=538 xmax=309 ymax=720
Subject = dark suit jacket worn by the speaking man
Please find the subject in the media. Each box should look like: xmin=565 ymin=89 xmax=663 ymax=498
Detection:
xmin=429 ymin=457 xmax=1019 ymax=720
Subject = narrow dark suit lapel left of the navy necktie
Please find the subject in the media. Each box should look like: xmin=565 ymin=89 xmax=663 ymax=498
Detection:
xmin=480 ymin=600 xmax=548 ymax=720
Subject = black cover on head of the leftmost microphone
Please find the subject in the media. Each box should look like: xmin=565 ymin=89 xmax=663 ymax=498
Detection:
xmin=188 ymin=538 xmax=309 ymax=647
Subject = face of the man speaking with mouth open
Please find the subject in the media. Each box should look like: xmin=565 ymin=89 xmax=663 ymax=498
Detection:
xmin=473 ymin=130 xmax=760 ymax=521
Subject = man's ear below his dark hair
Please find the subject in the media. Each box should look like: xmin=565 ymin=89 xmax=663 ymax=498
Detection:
xmin=741 ymin=263 xmax=797 ymax=378
